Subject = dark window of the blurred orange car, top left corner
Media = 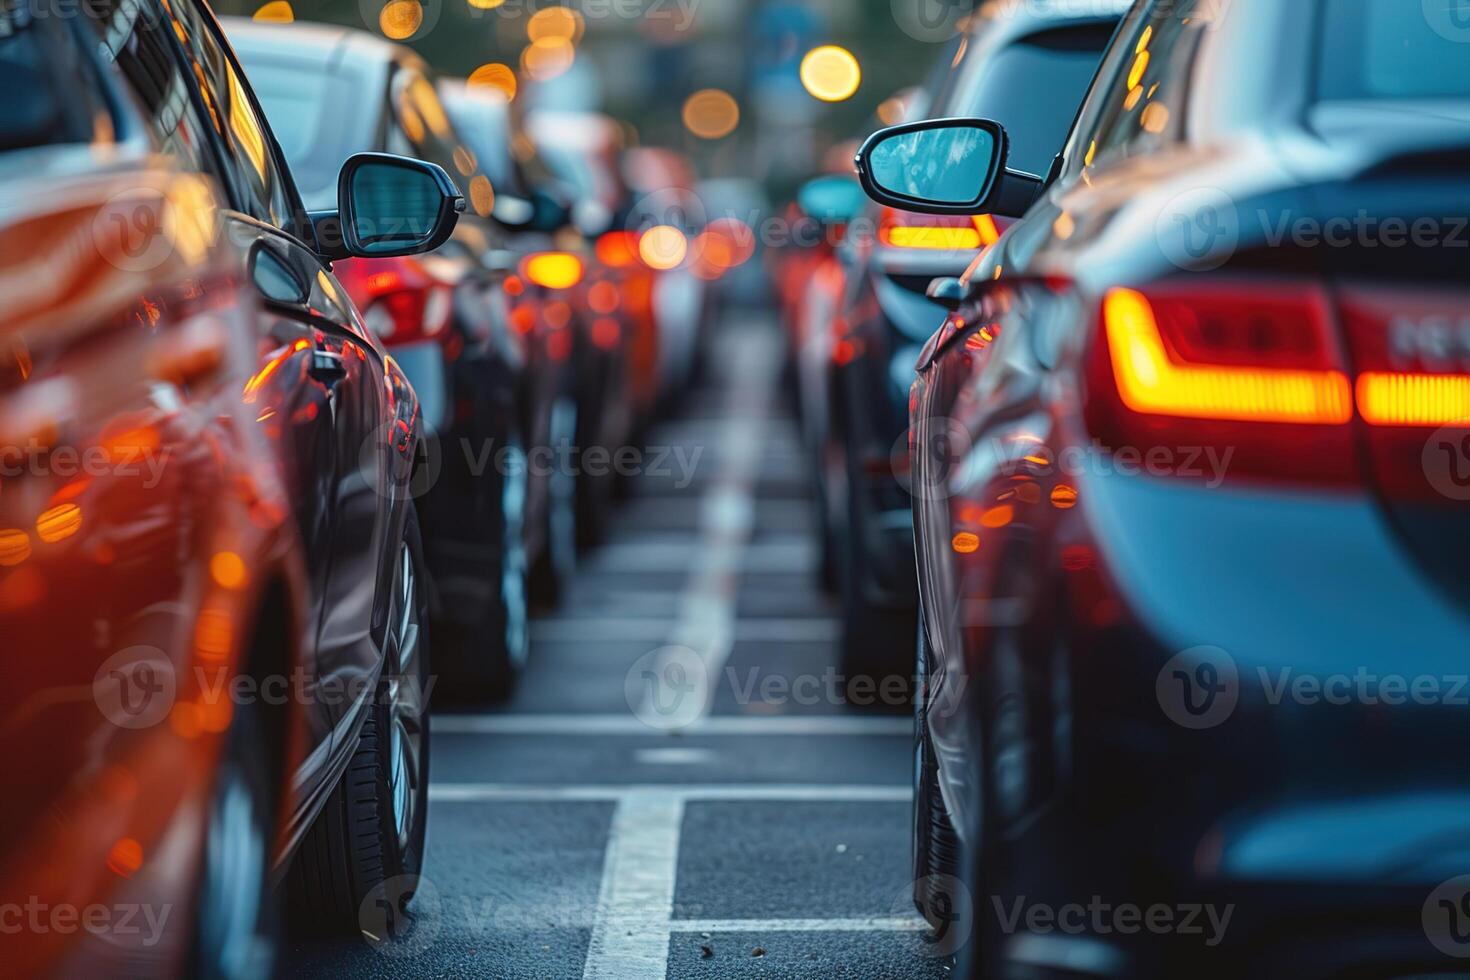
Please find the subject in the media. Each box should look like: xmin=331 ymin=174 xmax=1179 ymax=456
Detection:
xmin=0 ymin=6 xmax=118 ymax=151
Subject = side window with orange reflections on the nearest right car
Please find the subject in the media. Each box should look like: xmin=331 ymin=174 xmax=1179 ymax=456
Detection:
xmin=1083 ymin=0 xmax=1220 ymax=178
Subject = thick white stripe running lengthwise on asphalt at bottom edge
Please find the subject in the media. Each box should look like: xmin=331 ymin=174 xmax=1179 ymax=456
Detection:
xmin=582 ymin=790 xmax=684 ymax=980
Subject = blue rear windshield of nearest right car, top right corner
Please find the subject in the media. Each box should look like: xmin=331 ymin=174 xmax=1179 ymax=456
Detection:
xmin=1320 ymin=0 xmax=1470 ymax=101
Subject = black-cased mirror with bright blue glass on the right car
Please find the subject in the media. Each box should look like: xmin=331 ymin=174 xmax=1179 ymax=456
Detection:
xmin=857 ymin=119 xmax=1045 ymax=217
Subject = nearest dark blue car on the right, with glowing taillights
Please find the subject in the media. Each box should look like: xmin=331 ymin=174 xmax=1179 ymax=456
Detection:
xmin=860 ymin=0 xmax=1470 ymax=977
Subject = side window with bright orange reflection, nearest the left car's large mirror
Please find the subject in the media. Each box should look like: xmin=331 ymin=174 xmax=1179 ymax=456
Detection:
xmin=163 ymin=0 xmax=293 ymax=228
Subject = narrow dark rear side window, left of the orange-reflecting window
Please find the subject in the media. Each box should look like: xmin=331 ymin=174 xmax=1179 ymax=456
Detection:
xmin=85 ymin=0 xmax=221 ymax=179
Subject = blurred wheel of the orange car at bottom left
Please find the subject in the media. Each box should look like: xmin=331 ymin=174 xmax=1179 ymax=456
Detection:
xmin=188 ymin=690 xmax=279 ymax=980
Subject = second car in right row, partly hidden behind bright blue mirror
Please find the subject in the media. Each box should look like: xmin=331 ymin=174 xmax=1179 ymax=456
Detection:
xmin=819 ymin=0 xmax=1127 ymax=690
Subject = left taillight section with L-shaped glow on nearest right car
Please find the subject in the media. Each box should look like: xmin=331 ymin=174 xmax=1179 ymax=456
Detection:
xmin=1086 ymin=279 xmax=1358 ymax=486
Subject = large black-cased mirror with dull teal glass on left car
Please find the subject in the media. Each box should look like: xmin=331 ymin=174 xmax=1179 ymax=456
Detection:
xmin=331 ymin=153 xmax=465 ymax=259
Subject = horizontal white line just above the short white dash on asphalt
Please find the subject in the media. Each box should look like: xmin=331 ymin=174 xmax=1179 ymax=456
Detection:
xmin=434 ymin=714 xmax=913 ymax=738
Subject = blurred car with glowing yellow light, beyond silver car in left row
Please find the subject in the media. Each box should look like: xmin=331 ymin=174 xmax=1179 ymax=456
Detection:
xmin=440 ymin=79 xmax=637 ymax=547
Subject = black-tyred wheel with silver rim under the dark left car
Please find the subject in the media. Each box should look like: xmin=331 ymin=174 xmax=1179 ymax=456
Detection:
xmin=290 ymin=510 xmax=429 ymax=942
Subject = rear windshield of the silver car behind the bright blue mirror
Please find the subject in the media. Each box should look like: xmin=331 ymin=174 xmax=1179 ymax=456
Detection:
xmin=932 ymin=24 xmax=1114 ymax=173
